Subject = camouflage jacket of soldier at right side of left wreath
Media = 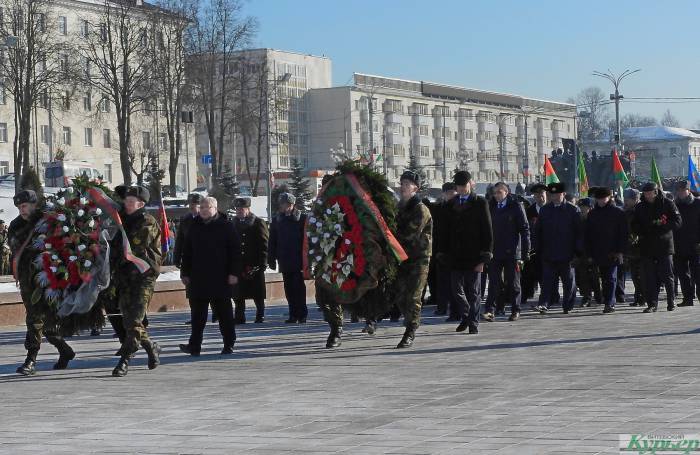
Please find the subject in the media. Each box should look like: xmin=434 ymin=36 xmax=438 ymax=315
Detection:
xmin=112 ymin=209 xmax=163 ymax=277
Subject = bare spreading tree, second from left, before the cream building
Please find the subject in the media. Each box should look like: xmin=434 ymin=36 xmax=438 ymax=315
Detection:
xmin=81 ymin=0 xmax=153 ymax=185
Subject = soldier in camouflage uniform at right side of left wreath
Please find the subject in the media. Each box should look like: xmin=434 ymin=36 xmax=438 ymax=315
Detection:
xmin=112 ymin=186 xmax=162 ymax=376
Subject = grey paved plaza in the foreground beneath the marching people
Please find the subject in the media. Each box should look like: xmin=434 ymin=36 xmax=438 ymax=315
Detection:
xmin=0 ymin=294 xmax=700 ymax=455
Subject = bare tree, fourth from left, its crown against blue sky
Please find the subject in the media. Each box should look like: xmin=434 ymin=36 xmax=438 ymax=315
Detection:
xmin=186 ymin=0 xmax=257 ymax=185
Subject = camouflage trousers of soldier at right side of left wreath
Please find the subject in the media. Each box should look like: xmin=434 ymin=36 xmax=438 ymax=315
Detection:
xmin=116 ymin=274 xmax=156 ymax=354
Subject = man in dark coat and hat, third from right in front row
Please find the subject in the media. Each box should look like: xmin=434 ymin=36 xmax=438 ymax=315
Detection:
xmin=584 ymin=187 xmax=629 ymax=313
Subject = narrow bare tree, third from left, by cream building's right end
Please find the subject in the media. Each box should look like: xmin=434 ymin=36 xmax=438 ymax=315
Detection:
xmin=149 ymin=0 xmax=191 ymax=191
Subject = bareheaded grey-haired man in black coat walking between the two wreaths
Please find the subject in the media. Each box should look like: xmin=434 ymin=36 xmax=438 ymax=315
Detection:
xmin=180 ymin=197 xmax=240 ymax=356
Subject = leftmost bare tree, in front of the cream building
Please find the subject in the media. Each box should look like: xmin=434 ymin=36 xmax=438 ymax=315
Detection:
xmin=0 ymin=0 xmax=72 ymax=188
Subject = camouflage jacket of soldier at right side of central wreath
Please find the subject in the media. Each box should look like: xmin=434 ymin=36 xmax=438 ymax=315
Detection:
xmin=396 ymin=196 xmax=433 ymax=265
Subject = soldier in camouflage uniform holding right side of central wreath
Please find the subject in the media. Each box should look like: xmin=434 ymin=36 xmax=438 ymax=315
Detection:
xmin=394 ymin=171 xmax=433 ymax=348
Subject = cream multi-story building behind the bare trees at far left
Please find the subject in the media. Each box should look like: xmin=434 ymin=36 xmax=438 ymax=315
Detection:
xmin=0 ymin=0 xmax=197 ymax=188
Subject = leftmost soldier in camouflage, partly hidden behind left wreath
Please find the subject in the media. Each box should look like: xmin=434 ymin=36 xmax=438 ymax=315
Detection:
xmin=8 ymin=190 xmax=75 ymax=376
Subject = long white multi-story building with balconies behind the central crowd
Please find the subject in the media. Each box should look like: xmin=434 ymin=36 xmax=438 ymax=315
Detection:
xmin=307 ymin=74 xmax=575 ymax=187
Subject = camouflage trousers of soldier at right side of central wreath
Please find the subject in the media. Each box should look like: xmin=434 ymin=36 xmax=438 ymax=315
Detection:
xmin=393 ymin=261 xmax=428 ymax=330
